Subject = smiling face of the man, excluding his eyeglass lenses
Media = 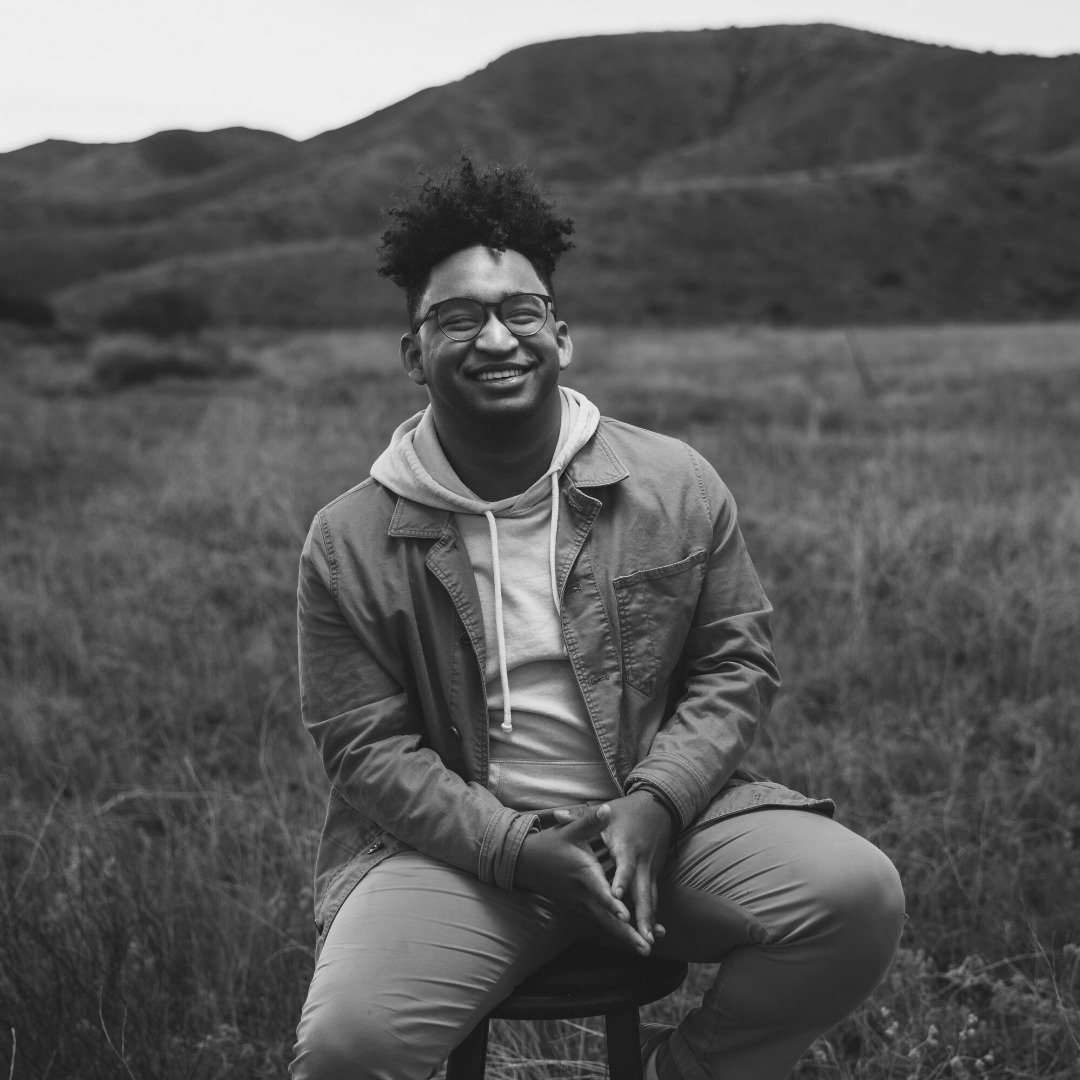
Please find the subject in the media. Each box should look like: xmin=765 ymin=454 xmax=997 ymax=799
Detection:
xmin=402 ymin=246 xmax=573 ymax=433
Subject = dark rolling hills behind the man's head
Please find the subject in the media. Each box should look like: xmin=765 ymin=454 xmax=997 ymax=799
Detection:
xmin=0 ymin=26 xmax=1080 ymax=326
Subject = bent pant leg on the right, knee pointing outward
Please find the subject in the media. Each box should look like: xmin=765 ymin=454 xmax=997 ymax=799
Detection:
xmin=658 ymin=809 xmax=904 ymax=1080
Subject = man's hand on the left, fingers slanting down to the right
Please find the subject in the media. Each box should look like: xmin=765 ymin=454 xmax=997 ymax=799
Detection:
xmin=514 ymin=800 xmax=652 ymax=956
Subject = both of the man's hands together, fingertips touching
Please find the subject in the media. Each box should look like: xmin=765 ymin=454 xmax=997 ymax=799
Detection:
xmin=514 ymin=792 xmax=672 ymax=956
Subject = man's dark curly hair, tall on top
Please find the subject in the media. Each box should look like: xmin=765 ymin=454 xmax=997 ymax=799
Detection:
xmin=378 ymin=153 xmax=573 ymax=325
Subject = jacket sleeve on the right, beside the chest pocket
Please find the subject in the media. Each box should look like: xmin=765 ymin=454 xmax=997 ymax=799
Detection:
xmin=626 ymin=447 xmax=780 ymax=828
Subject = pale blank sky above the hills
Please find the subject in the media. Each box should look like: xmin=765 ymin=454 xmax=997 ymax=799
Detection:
xmin=0 ymin=0 xmax=1080 ymax=152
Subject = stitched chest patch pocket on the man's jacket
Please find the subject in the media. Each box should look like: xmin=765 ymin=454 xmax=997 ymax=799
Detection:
xmin=612 ymin=551 xmax=705 ymax=696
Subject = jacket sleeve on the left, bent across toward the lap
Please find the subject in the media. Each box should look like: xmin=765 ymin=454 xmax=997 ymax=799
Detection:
xmin=297 ymin=514 xmax=537 ymax=890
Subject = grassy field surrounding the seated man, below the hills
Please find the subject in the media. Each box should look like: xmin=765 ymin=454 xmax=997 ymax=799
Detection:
xmin=0 ymin=315 xmax=1080 ymax=1080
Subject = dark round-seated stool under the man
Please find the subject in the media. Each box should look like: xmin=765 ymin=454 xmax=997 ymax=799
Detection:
xmin=446 ymin=942 xmax=687 ymax=1080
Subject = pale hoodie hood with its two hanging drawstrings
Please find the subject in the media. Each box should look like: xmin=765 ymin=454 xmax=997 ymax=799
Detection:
xmin=372 ymin=387 xmax=600 ymax=732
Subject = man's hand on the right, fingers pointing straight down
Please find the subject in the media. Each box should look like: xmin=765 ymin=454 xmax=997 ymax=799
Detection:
xmin=604 ymin=792 xmax=673 ymax=945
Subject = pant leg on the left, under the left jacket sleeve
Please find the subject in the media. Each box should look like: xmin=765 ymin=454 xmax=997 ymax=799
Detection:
xmin=291 ymin=851 xmax=581 ymax=1080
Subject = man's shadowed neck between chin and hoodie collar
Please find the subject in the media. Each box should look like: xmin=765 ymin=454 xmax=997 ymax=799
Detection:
xmin=434 ymin=395 xmax=562 ymax=502
